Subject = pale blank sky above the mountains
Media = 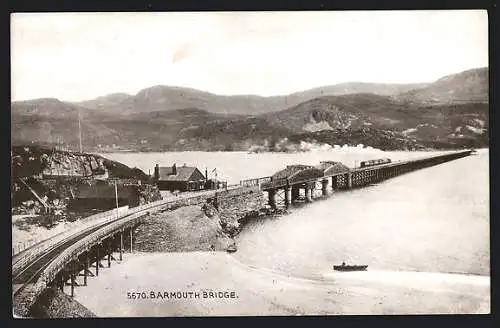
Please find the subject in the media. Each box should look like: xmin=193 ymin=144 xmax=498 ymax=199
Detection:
xmin=11 ymin=10 xmax=488 ymax=101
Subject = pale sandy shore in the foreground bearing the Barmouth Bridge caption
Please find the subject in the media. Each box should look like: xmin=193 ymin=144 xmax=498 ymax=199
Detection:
xmin=70 ymin=252 xmax=490 ymax=317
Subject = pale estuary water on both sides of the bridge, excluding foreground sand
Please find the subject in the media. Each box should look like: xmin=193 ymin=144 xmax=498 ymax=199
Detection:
xmin=103 ymin=148 xmax=490 ymax=279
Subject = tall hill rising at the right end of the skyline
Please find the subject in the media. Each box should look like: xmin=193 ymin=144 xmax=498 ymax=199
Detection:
xmin=395 ymin=67 xmax=489 ymax=104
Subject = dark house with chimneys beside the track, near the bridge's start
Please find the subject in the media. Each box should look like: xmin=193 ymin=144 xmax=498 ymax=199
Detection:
xmin=153 ymin=164 xmax=207 ymax=191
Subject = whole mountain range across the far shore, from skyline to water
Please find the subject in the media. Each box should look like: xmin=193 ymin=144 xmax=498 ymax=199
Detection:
xmin=11 ymin=68 xmax=489 ymax=151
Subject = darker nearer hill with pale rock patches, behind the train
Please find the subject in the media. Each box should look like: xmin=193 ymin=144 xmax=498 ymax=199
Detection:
xmin=265 ymin=94 xmax=489 ymax=147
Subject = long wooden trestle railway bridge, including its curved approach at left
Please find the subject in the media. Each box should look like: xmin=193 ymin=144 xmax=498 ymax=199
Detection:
xmin=12 ymin=150 xmax=473 ymax=316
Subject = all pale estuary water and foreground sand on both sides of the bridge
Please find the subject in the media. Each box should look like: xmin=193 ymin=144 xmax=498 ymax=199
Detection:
xmin=71 ymin=149 xmax=490 ymax=317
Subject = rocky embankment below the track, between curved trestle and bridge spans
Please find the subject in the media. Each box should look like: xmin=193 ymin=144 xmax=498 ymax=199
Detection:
xmin=135 ymin=187 xmax=266 ymax=252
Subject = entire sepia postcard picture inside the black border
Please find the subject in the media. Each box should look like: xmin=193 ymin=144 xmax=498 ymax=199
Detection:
xmin=10 ymin=9 xmax=491 ymax=319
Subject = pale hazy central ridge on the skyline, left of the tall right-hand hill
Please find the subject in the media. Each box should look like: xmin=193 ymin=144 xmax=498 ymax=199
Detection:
xmin=73 ymin=82 xmax=425 ymax=115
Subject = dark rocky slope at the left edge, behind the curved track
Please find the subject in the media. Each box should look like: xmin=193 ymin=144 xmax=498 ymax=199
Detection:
xmin=11 ymin=146 xmax=161 ymax=215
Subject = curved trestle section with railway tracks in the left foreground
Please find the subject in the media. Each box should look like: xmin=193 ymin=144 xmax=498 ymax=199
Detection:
xmin=12 ymin=190 xmax=227 ymax=317
